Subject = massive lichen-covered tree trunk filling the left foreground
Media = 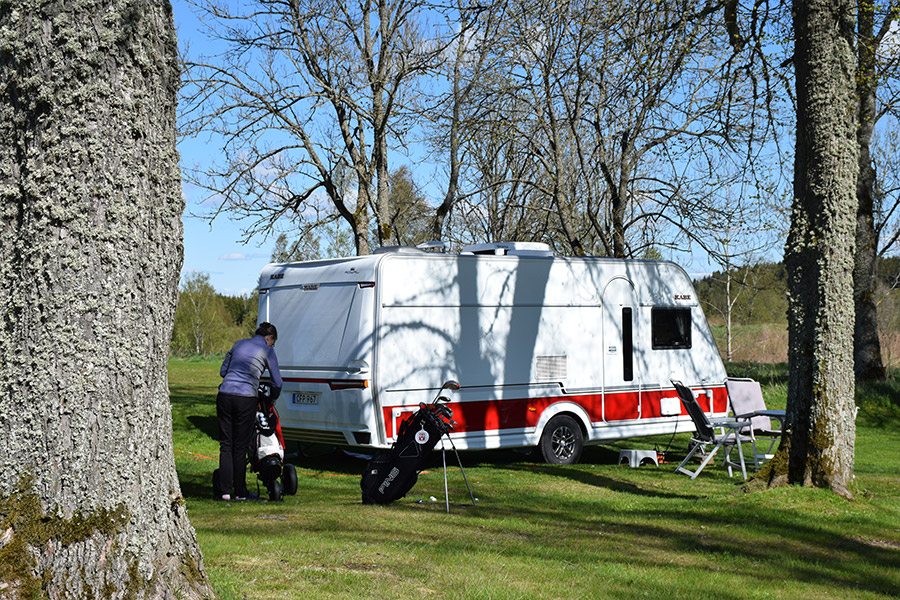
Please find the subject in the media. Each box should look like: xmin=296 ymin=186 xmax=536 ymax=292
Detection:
xmin=0 ymin=0 xmax=212 ymax=598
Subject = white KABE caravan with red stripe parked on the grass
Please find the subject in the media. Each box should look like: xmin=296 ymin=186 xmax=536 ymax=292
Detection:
xmin=259 ymin=242 xmax=727 ymax=463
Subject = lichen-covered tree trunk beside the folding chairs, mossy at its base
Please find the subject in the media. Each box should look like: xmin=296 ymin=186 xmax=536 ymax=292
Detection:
xmin=774 ymin=0 xmax=859 ymax=495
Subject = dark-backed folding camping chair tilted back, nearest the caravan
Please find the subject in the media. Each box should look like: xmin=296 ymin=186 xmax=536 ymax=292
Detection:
xmin=672 ymin=380 xmax=750 ymax=479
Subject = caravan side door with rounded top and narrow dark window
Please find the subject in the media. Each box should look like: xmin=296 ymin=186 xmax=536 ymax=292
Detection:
xmin=602 ymin=276 xmax=641 ymax=421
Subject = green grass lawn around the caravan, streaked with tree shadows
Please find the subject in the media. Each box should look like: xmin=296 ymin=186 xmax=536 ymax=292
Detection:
xmin=169 ymin=359 xmax=900 ymax=600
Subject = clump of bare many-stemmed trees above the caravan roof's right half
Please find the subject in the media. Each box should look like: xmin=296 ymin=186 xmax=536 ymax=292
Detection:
xmin=442 ymin=0 xmax=771 ymax=257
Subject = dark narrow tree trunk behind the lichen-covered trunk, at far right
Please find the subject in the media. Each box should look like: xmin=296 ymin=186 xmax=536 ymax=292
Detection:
xmin=853 ymin=0 xmax=886 ymax=381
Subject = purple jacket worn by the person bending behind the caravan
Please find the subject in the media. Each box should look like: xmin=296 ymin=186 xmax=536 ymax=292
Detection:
xmin=219 ymin=335 xmax=283 ymax=400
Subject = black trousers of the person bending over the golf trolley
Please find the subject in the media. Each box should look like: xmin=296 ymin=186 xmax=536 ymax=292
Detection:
xmin=215 ymin=392 xmax=257 ymax=498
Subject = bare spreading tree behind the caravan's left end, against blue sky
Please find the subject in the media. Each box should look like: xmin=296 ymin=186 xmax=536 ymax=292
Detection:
xmin=183 ymin=0 xmax=435 ymax=254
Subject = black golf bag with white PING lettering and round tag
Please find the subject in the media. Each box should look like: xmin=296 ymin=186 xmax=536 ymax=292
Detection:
xmin=360 ymin=398 xmax=458 ymax=504
